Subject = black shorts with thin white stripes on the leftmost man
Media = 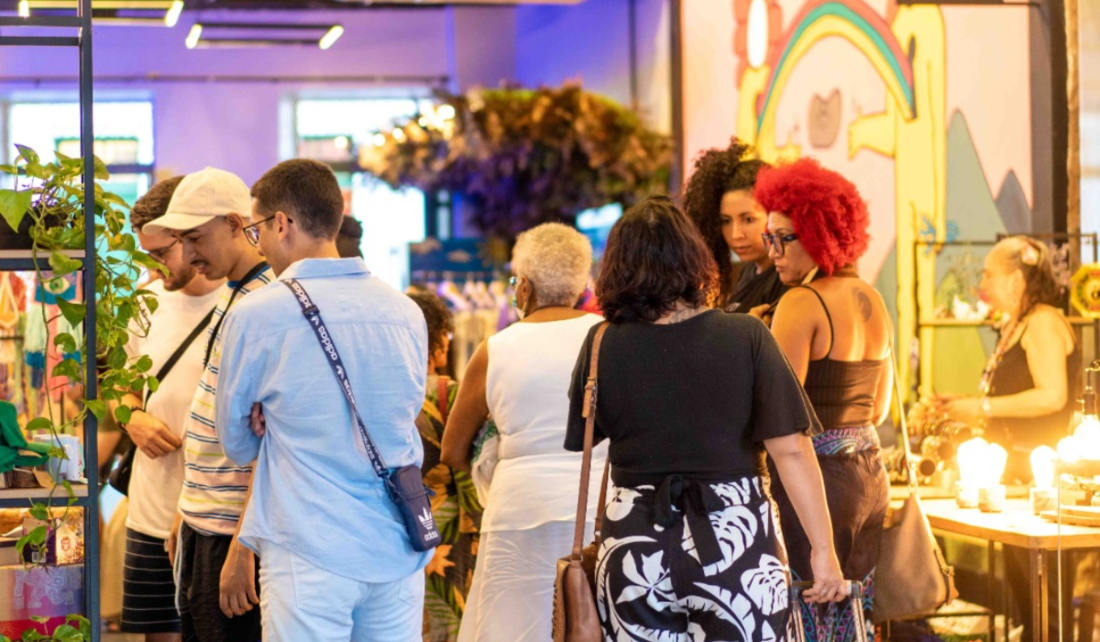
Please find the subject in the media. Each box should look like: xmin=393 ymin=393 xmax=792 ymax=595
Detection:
xmin=122 ymin=529 xmax=179 ymax=633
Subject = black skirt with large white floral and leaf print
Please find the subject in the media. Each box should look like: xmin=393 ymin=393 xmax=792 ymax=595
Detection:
xmin=596 ymin=476 xmax=791 ymax=642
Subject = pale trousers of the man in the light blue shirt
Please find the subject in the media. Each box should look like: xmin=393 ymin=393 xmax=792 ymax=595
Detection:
xmin=260 ymin=542 xmax=425 ymax=642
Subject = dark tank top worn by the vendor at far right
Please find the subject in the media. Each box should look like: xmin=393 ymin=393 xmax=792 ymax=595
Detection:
xmin=989 ymin=318 xmax=1081 ymax=450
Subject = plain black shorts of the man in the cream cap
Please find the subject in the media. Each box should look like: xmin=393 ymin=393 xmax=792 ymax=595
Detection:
xmin=179 ymin=522 xmax=262 ymax=642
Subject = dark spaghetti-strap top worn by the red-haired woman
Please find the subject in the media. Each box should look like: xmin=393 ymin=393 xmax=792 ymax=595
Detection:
xmin=801 ymin=286 xmax=890 ymax=430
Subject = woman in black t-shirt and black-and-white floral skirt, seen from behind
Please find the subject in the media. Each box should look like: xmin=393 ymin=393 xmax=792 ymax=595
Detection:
xmin=565 ymin=197 xmax=847 ymax=642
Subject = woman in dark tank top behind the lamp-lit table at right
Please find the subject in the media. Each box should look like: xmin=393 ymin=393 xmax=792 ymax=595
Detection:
xmin=945 ymin=236 xmax=1081 ymax=480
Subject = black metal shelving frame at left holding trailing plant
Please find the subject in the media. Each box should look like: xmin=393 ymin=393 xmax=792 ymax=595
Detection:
xmin=0 ymin=0 xmax=100 ymax=642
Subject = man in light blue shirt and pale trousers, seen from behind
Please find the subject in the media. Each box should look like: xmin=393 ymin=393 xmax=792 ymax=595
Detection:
xmin=216 ymin=159 xmax=431 ymax=642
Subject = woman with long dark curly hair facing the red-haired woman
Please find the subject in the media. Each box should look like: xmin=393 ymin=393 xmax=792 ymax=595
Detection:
xmin=683 ymin=139 xmax=785 ymax=317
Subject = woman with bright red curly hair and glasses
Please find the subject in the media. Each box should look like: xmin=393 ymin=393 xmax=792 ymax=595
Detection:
xmin=755 ymin=158 xmax=893 ymax=642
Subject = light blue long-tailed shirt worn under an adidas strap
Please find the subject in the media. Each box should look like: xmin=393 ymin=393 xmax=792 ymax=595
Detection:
xmin=216 ymin=258 xmax=431 ymax=583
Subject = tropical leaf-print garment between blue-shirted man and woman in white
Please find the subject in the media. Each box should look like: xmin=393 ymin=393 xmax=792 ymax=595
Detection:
xmin=417 ymin=377 xmax=482 ymax=642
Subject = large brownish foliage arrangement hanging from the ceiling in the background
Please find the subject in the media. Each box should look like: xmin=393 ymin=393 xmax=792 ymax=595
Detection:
xmin=360 ymin=85 xmax=672 ymax=237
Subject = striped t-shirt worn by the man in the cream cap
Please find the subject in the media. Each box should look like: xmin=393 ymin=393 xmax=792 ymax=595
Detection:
xmin=179 ymin=267 xmax=275 ymax=535
